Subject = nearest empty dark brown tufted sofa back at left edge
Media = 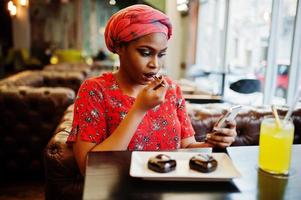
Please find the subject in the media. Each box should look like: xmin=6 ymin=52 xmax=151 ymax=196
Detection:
xmin=0 ymin=86 xmax=75 ymax=178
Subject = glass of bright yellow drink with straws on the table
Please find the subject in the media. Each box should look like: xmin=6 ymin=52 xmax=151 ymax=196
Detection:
xmin=259 ymin=117 xmax=294 ymax=175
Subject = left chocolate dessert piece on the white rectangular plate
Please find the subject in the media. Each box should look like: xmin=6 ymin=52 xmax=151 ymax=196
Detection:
xmin=147 ymin=154 xmax=177 ymax=173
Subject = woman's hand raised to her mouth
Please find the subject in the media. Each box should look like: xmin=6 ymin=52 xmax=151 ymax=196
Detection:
xmin=134 ymin=78 xmax=168 ymax=112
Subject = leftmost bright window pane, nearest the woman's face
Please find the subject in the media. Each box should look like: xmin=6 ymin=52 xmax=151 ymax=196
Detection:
xmin=186 ymin=0 xmax=225 ymax=95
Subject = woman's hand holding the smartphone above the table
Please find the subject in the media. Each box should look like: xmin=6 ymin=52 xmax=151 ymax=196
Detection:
xmin=206 ymin=120 xmax=237 ymax=148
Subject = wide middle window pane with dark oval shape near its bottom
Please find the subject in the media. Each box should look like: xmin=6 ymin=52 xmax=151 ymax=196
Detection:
xmin=225 ymin=0 xmax=272 ymax=105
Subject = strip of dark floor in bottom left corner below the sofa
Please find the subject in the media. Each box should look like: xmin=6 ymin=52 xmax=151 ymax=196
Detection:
xmin=0 ymin=180 xmax=44 ymax=200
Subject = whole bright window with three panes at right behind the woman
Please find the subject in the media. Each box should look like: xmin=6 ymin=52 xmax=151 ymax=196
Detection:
xmin=187 ymin=0 xmax=297 ymax=105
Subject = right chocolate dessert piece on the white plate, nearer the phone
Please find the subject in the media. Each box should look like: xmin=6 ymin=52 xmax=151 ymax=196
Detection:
xmin=189 ymin=154 xmax=217 ymax=173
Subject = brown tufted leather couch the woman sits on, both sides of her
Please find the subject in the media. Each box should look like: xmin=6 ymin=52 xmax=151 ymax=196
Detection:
xmin=44 ymin=104 xmax=301 ymax=199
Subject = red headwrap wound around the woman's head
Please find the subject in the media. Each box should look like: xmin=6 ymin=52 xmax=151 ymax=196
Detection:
xmin=105 ymin=5 xmax=172 ymax=53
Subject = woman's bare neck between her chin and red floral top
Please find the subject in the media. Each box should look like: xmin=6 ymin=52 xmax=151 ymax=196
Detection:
xmin=113 ymin=70 xmax=144 ymax=97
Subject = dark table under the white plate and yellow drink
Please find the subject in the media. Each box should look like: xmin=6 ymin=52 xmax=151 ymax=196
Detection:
xmin=83 ymin=145 xmax=301 ymax=200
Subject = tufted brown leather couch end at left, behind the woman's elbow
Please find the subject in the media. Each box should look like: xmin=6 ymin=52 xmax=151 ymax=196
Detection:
xmin=44 ymin=105 xmax=84 ymax=200
